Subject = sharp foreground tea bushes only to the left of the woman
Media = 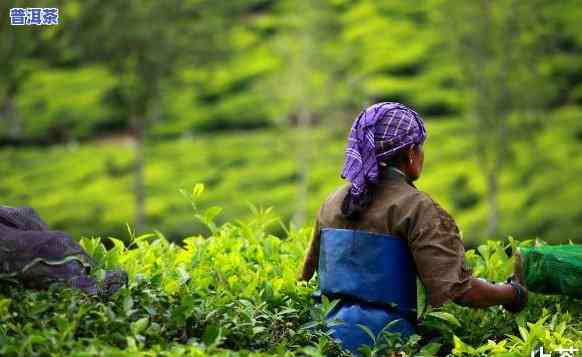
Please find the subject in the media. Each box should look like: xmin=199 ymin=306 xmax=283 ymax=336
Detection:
xmin=0 ymin=192 xmax=332 ymax=355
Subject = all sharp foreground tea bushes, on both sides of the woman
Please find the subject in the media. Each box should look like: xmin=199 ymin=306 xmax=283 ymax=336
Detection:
xmin=0 ymin=185 xmax=582 ymax=356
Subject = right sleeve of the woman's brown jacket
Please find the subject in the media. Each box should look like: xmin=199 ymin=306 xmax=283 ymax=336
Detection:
xmin=409 ymin=193 xmax=472 ymax=306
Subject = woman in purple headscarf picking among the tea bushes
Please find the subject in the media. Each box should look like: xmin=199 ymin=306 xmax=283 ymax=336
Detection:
xmin=301 ymin=102 xmax=527 ymax=351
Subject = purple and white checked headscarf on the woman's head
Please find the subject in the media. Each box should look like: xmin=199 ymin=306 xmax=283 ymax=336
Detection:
xmin=341 ymin=102 xmax=427 ymax=202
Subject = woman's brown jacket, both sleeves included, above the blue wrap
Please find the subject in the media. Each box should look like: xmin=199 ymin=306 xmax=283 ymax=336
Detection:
xmin=302 ymin=168 xmax=472 ymax=306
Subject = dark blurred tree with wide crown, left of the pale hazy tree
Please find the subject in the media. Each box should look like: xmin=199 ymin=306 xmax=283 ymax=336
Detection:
xmin=70 ymin=0 xmax=237 ymax=231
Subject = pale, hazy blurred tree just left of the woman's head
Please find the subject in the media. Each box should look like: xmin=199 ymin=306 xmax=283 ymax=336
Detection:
xmin=266 ymin=0 xmax=346 ymax=225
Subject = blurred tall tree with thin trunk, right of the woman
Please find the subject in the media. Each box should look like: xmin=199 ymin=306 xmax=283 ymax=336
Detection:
xmin=440 ymin=0 xmax=546 ymax=236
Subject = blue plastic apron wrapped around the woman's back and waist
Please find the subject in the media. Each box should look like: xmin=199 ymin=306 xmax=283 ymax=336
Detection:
xmin=317 ymin=228 xmax=416 ymax=353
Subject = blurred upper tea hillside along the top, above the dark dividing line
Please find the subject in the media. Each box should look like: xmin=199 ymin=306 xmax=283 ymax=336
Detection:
xmin=0 ymin=0 xmax=582 ymax=141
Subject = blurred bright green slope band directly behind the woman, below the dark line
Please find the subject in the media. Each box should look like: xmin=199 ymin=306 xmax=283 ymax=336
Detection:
xmin=0 ymin=108 xmax=582 ymax=244
